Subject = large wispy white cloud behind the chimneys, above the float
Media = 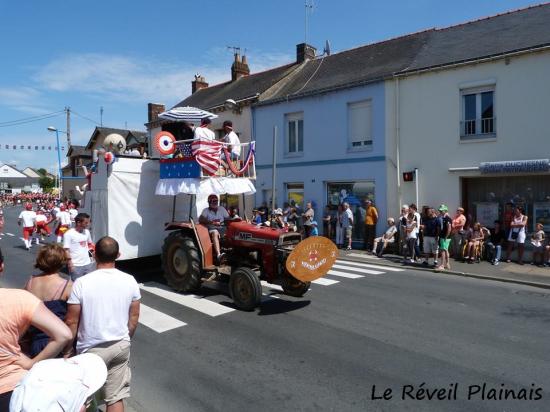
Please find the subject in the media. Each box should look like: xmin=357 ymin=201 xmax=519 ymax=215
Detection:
xmin=31 ymin=48 xmax=292 ymax=107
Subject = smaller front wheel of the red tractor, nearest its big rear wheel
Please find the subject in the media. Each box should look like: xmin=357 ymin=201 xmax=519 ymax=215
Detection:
xmin=229 ymin=267 xmax=262 ymax=311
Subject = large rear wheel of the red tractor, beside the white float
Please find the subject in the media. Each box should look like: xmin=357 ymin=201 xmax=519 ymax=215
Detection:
xmin=162 ymin=231 xmax=201 ymax=292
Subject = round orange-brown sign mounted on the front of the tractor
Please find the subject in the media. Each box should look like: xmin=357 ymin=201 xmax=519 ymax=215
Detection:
xmin=286 ymin=236 xmax=338 ymax=282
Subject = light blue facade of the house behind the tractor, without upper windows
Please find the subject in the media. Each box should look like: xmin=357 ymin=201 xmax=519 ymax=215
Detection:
xmin=252 ymin=82 xmax=387 ymax=241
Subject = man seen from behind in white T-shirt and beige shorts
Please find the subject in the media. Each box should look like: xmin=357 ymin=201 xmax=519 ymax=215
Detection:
xmin=64 ymin=236 xmax=141 ymax=412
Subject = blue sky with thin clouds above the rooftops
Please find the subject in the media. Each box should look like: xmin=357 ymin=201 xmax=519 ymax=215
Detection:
xmin=0 ymin=0 xmax=539 ymax=169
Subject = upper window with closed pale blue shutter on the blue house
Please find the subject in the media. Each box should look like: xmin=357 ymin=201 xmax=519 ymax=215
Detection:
xmin=348 ymin=100 xmax=372 ymax=150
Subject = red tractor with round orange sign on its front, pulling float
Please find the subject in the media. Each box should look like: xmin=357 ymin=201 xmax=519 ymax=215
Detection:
xmin=162 ymin=220 xmax=337 ymax=310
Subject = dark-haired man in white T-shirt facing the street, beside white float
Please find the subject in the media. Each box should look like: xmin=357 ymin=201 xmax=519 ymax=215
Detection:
xmin=63 ymin=213 xmax=95 ymax=282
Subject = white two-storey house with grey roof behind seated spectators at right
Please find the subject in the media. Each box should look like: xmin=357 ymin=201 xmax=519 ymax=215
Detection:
xmin=386 ymin=4 xmax=550 ymax=230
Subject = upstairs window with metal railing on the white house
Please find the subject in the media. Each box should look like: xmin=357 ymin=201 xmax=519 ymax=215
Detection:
xmin=460 ymin=88 xmax=496 ymax=140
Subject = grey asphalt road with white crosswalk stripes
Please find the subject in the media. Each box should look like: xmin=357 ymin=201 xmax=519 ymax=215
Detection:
xmin=0 ymin=209 xmax=550 ymax=412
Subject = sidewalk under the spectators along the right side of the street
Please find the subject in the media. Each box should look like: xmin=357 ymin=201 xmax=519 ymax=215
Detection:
xmin=340 ymin=249 xmax=550 ymax=289
